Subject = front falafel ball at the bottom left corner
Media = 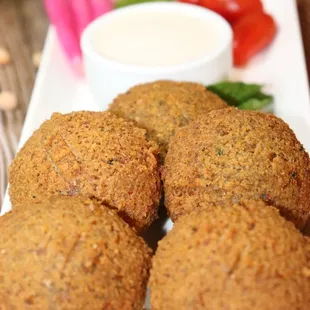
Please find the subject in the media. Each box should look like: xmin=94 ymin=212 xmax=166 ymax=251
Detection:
xmin=0 ymin=197 xmax=151 ymax=310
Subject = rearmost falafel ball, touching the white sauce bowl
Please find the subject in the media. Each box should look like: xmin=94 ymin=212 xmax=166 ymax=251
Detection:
xmin=110 ymin=81 xmax=227 ymax=160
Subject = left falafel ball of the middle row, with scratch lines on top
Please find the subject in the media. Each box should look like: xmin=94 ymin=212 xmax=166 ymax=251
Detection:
xmin=9 ymin=112 xmax=160 ymax=230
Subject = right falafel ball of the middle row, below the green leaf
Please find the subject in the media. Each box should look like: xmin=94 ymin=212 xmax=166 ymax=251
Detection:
xmin=162 ymin=108 xmax=310 ymax=228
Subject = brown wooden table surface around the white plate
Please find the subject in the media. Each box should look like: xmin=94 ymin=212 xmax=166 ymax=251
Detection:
xmin=0 ymin=0 xmax=310 ymax=206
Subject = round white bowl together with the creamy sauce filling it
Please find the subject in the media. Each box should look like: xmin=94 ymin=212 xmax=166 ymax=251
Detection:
xmin=81 ymin=1 xmax=232 ymax=104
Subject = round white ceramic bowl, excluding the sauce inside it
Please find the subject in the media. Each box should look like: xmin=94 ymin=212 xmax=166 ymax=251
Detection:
xmin=81 ymin=2 xmax=232 ymax=106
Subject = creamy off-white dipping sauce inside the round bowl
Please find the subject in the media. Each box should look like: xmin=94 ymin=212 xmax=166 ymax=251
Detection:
xmin=92 ymin=10 xmax=220 ymax=67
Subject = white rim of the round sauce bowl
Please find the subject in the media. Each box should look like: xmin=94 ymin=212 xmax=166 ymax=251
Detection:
xmin=80 ymin=2 xmax=233 ymax=75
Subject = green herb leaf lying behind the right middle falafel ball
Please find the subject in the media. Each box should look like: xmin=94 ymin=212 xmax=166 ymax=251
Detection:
xmin=207 ymin=81 xmax=273 ymax=110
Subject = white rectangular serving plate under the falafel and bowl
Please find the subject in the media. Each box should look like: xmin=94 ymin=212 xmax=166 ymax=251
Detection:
xmin=1 ymin=0 xmax=310 ymax=308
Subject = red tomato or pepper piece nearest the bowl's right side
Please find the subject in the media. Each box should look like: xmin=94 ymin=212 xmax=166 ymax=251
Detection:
xmin=233 ymin=12 xmax=277 ymax=66
